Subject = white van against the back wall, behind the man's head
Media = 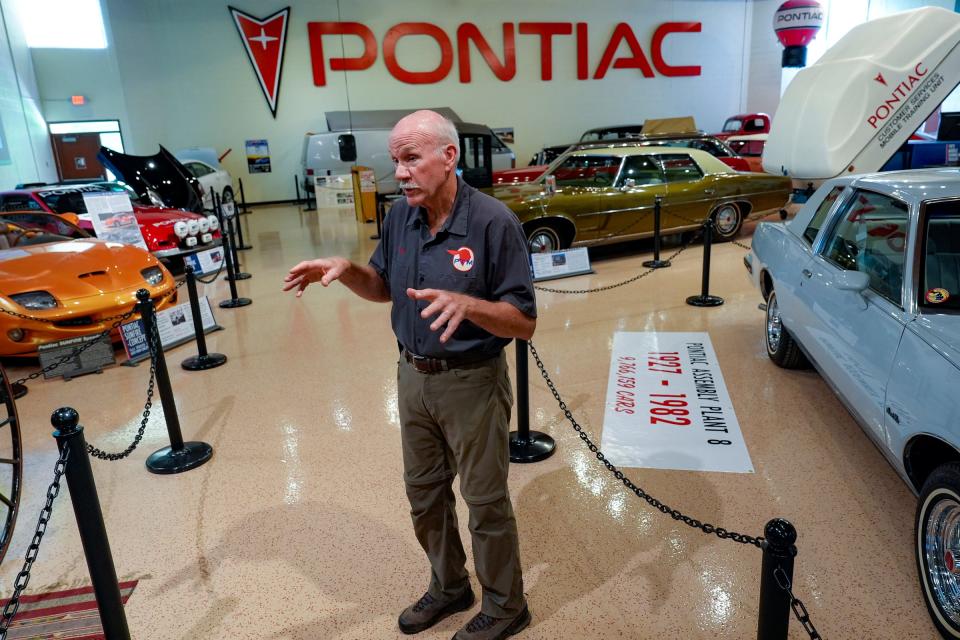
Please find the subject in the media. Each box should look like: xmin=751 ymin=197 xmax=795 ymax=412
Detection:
xmin=301 ymin=108 xmax=516 ymax=195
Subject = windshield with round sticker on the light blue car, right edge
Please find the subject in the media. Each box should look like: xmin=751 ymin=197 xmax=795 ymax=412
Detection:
xmin=918 ymin=200 xmax=960 ymax=313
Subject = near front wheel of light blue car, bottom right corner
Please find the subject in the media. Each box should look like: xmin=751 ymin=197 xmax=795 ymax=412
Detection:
xmin=916 ymin=462 xmax=960 ymax=638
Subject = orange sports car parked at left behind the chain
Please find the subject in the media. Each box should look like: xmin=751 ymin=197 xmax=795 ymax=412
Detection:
xmin=0 ymin=211 xmax=177 ymax=356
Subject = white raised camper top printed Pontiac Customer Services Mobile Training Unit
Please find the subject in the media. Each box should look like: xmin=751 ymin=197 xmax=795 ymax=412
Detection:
xmin=763 ymin=7 xmax=960 ymax=180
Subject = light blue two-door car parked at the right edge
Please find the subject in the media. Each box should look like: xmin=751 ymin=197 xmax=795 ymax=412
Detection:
xmin=744 ymin=169 xmax=960 ymax=638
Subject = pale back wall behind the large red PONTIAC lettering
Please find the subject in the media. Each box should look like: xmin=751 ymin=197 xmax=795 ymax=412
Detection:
xmin=80 ymin=0 xmax=756 ymax=200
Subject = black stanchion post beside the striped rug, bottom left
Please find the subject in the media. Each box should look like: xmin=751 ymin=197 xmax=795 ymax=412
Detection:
xmin=50 ymin=407 xmax=130 ymax=640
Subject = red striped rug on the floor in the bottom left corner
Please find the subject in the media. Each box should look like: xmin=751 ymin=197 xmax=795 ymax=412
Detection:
xmin=3 ymin=580 xmax=137 ymax=640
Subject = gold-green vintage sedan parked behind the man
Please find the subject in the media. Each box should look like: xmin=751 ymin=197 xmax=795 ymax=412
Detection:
xmin=494 ymin=144 xmax=791 ymax=252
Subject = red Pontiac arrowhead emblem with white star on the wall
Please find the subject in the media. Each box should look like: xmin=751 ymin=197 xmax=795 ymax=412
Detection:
xmin=227 ymin=7 xmax=290 ymax=118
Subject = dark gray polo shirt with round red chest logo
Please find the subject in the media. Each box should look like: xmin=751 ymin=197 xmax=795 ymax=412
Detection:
xmin=370 ymin=177 xmax=537 ymax=358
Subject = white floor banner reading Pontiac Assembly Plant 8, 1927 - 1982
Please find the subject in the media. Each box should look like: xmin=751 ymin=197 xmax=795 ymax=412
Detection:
xmin=601 ymin=332 xmax=753 ymax=473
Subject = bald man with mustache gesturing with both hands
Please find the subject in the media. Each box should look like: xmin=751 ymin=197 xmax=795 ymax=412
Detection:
xmin=284 ymin=111 xmax=537 ymax=640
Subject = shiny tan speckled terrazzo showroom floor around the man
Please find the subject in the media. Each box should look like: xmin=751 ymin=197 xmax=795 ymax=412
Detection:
xmin=0 ymin=206 xmax=935 ymax=640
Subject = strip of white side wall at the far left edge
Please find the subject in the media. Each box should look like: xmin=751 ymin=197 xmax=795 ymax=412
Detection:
xmin=0 ymin=0 xmax=57 ymax=189
